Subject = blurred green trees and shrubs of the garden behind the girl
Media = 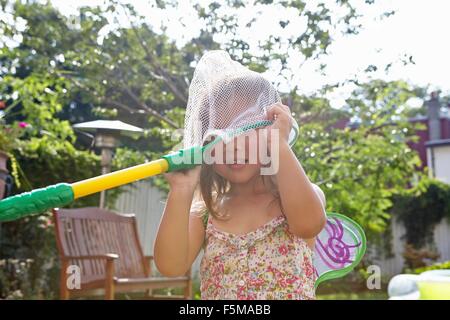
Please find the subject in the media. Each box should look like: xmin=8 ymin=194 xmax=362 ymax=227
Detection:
xmin=0 ymin=0 xmax=450 ymax=300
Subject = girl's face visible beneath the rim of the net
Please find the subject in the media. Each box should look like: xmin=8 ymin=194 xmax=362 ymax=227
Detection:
xmin=211 ymin=130 xmax=263 ymax=183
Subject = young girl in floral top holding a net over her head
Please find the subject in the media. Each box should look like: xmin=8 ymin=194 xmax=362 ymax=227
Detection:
xmin=154 ymin=60 xmax=326 ymax=299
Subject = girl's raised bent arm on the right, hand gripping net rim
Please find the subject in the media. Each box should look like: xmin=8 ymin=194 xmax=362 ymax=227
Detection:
xmin=269 ymin=105 xmax=326 ymax=239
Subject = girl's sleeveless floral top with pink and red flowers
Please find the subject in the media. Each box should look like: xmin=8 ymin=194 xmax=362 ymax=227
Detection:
xmin=200 ymin=215 xmax=316 ymax=300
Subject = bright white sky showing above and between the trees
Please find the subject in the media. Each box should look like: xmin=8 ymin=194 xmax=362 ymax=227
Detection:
xmin=52 ymin=0 xmax=450 ymax=107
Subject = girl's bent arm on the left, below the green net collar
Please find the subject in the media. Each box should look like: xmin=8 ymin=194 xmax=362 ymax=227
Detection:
xmin=154 ymin=167 xmax=205 ymax=277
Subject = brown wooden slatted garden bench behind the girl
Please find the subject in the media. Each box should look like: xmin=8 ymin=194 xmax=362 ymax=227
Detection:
xmin=53 ymin=208 xmax=192 ymax=300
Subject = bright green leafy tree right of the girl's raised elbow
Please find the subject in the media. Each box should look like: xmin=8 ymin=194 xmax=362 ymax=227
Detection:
xmin=294 ymin=80 xmax=426 ymax=234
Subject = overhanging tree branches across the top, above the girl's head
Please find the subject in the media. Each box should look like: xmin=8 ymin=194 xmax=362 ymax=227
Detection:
xmin=2 ymin=0 xmax=380 ymax=128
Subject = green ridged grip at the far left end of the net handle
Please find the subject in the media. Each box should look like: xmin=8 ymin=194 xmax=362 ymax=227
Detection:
xmin=0 ymin=183 xmax=74 ymax=221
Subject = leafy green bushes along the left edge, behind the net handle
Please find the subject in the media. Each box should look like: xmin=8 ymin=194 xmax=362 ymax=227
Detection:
xmin=0 ymin=2 xmax=100 ymax=298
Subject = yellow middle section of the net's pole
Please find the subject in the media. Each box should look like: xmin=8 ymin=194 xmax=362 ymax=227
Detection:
xmin=71 ymin=159 xmax=169 ymax=199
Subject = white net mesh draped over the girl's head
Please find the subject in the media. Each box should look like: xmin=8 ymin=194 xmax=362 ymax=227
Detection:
xmin=183 ymin=50 xmax=281 ymax=148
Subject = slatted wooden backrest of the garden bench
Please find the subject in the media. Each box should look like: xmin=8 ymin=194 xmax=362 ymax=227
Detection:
xmin=53 ymin=207 xmax=148 ymax=282
